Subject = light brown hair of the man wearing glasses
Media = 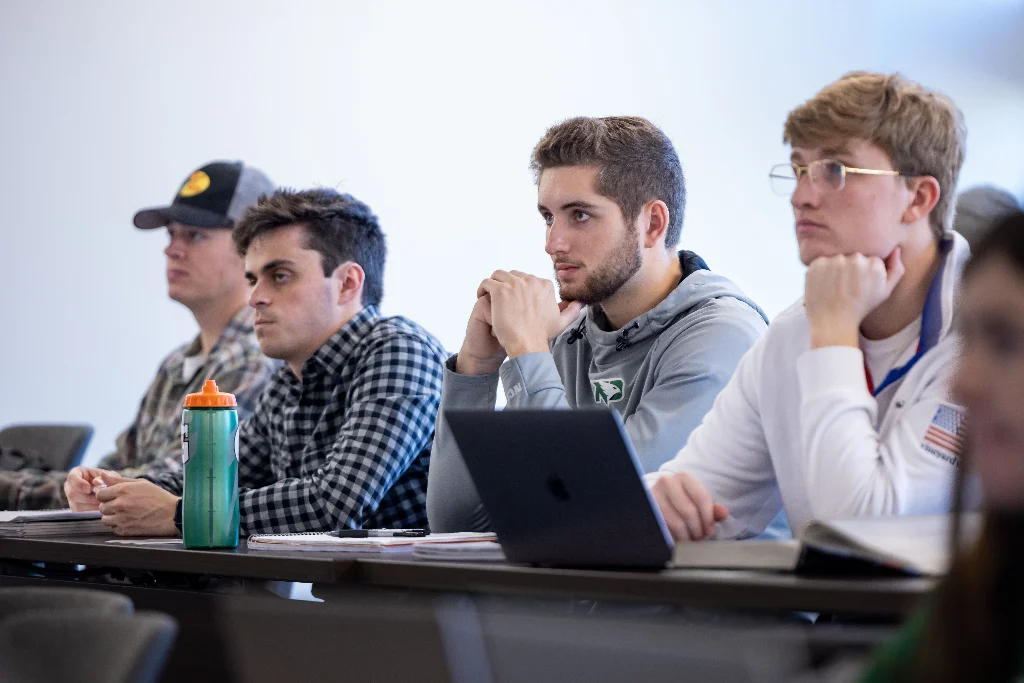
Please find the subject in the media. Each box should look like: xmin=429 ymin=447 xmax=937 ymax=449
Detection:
xmin=782 ymin=72 xmax=967 ymax=239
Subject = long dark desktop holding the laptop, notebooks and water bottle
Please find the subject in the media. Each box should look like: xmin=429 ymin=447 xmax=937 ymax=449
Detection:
xmin=0 ymin=537 xmax=934 ymax=617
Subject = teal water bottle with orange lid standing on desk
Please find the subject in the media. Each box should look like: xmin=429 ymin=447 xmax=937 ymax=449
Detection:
xmin=181 ymin=380 xmax=239 ymax=548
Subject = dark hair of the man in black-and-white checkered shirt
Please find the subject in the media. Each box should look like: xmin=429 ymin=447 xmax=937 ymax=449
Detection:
xmin=231 ymin=187 xmax=387 ymax=306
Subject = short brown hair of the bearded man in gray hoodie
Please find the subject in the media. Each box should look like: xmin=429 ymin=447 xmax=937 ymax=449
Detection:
xmin=529 ymin=116 xmax=686 ymax=247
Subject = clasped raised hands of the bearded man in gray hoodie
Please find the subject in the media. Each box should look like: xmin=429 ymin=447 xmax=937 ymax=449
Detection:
xmin=456 ymin=270 xmax=583 ymax=375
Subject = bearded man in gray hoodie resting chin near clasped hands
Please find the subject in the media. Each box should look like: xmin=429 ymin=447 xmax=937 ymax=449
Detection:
xmin=427 ymin=117 xmax=767 ymax=531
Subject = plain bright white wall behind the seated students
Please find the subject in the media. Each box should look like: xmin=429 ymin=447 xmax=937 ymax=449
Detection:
xmin=0 ymin=0 xmax=1024 ymax=462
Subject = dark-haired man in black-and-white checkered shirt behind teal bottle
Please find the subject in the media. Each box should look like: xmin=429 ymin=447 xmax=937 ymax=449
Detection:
xmin=66 ymin=189 xmax=445 ymax=536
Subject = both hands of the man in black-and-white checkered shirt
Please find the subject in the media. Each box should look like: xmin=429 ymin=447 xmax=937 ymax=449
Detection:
xmin=65 ymin=466 xmax=178 ymax=536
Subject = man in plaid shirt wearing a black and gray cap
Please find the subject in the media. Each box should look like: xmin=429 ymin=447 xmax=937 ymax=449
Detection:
xmin=0 ymin=161 xmax=276 ymax=510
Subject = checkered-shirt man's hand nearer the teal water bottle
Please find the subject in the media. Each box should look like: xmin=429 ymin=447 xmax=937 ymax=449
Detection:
xmin=96 ymin=478 xmax=178 ymax=536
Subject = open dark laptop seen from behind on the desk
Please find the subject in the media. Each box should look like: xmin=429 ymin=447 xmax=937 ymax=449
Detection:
xmin=444 ymin=409 xmax=673 ymax=568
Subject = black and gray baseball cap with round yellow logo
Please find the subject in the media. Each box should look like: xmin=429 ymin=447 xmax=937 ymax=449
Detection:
xmin=134 ymin=161 xmax=276 ymax=230
